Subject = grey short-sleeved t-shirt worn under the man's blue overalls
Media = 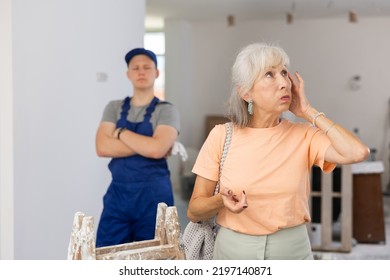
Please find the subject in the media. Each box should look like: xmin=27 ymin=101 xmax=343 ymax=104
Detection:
xmin=101 ymin=100 xmax=180 ymax=133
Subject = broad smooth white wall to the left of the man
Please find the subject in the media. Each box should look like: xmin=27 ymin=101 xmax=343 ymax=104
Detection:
xmin=6 ymin=0 xmax=145 ymax=259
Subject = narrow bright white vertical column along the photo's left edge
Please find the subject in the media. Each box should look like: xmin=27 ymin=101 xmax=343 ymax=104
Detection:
xmin=0 ymin=0 xmax=14 ymax=260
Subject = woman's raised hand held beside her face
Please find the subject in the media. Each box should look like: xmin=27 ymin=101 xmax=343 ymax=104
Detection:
xmin=288 ymin=72 xmax=311 ymax=118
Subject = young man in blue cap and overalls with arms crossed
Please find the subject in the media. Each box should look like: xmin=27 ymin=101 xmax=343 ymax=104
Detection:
xmin=96 ymin=48 xmax=180 ymax=247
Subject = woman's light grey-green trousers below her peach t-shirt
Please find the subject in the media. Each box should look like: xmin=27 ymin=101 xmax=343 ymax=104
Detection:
xmin=213 ymin=224 xmax=313 ymax=260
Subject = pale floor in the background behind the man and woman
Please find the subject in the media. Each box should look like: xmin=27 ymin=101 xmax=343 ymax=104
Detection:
xmin=175 ymin=184 xmax=390 ymax=260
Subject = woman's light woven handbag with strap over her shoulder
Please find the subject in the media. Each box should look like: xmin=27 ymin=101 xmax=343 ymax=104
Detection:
xmin=181 ymin=122 xmax=232 ymax=260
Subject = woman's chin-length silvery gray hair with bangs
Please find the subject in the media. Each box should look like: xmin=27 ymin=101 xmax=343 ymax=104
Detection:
xmin=227 ymin=43 xmax=290 ymax=127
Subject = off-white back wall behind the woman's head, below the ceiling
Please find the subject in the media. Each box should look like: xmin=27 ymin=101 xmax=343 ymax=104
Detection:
xmin=166 ymin=18 xmax=390 ymax=190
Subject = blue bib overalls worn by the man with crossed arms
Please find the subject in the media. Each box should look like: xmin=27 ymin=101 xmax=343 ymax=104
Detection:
xmin=96 ymin=97 xmax=173 ymax=247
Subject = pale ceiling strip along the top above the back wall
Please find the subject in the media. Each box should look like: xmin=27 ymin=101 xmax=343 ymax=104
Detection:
xmin=145 ymin=0 xmax=390 ymax=29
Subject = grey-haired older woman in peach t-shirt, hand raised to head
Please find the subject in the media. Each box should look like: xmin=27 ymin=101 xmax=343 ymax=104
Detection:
xmin=187 ymin=43 xmax=369 ymax=260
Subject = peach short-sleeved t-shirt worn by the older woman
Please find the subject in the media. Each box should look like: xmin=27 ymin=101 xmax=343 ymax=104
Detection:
xmin=192 ymin=120 xmax=336 ymax=235
